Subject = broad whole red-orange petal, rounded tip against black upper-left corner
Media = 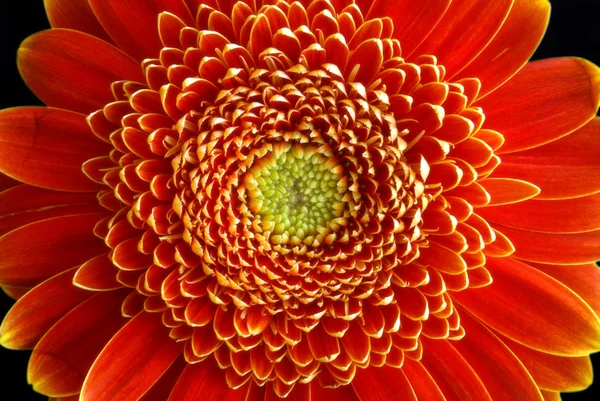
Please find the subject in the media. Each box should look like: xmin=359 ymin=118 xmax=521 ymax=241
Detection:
xmin=17 ymin=29 xmax=144 ymax=114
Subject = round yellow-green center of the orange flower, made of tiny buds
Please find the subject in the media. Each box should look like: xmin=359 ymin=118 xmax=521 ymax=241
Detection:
xmin=244 ymin=144 xmax=347 ymax=246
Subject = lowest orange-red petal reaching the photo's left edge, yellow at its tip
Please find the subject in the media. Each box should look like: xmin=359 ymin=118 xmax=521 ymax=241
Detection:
xmin=0 ymin=269 xmax=93 ymax=349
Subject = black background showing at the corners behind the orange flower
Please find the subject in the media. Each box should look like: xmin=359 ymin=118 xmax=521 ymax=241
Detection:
xmin=0 ymin=0 xmax=600 ymax=401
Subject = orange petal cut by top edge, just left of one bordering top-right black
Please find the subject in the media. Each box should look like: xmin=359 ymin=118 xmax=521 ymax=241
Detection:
xmin=413 ymin=0 xmax=513 ymax=78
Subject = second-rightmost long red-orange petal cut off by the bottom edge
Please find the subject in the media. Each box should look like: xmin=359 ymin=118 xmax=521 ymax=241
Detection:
xmin=421 ymin=338 xmax=492 ymax=401
